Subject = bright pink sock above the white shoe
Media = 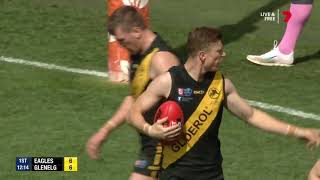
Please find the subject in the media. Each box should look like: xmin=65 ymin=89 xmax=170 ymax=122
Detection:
xmin=279 ymin=4 xmax=312 ymax=54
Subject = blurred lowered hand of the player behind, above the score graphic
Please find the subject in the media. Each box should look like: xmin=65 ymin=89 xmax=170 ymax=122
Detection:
xmin=86 ymin=131 xmax=106 ymax=160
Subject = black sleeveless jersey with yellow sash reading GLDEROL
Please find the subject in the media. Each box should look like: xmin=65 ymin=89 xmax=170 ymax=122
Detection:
xmin=162 ymin=66 xmax=224 ymax=179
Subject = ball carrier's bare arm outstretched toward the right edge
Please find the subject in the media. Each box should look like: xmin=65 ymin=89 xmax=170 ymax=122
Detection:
xmin=224 ymin=79 xmax=320 ymax=146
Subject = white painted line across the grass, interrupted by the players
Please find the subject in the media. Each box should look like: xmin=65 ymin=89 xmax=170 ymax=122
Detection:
xmin=0 ymin=56 xmax=320 ymax=121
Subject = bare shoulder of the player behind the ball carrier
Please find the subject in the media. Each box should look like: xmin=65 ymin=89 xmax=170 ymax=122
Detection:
xmin=149 ymin=51 xmax=179 ymax=79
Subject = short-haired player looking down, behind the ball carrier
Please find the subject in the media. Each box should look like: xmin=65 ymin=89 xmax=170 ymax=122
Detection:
xmin=87 ymin=6 xmax=179 ymax=180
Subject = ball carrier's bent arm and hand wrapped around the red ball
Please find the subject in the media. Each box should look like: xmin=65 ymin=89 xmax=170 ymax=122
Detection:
xmin=127 ymin=72 xmax=181 ymax=139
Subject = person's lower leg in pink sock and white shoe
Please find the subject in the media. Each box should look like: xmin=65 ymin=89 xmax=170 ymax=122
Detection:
xmin=247 ymin=0 xmax=313 ymax=66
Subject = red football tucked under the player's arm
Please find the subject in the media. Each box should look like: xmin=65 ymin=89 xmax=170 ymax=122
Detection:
xmin=154 ymin=101 xmax=184 ymax=127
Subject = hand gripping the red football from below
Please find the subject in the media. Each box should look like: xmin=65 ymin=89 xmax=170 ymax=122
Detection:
xmin=147 ymin=117 xmax=181 ymax=141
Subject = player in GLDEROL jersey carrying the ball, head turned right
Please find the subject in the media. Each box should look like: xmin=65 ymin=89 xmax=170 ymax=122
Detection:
xmin=128 ymin=27 xmax=320 ymax=180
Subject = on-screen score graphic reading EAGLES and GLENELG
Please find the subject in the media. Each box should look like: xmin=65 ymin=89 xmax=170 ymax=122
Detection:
xmin=16 ymin=157 xmax=78 ymax=172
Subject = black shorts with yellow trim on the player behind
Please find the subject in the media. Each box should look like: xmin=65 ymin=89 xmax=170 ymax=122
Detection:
xmin=133 ymin=143 xmax=162 ymax=178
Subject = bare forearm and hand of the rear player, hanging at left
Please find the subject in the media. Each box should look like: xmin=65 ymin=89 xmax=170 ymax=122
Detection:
xmin=86 ymin=96 xmax=134 ymax=159
